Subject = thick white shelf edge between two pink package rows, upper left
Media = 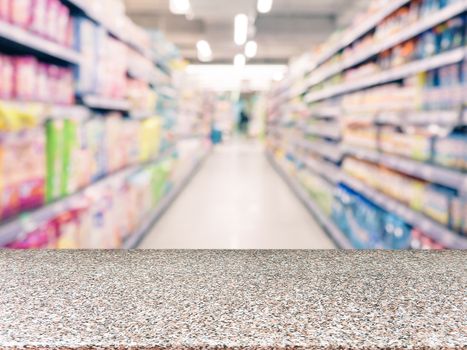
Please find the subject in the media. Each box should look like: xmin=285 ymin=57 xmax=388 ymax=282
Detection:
xmin=0 ymin=21 xmax=81 ymax=64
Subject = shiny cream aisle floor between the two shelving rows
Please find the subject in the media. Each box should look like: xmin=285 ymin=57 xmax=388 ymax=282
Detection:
xmin=140 ymin=140 xmax=335 ymax=249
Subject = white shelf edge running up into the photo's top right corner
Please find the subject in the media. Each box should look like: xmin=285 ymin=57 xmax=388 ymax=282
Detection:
xmin=304 ymin=0 xmax=467 ymax=96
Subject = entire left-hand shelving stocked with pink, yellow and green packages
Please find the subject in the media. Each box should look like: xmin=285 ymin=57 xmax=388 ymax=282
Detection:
xmin=0 ymin=0 xmax=210 ymax=248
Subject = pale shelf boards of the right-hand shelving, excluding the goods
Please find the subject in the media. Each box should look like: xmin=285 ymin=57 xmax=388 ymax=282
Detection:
xmin=269 ymin=0 xmax=467 ymax=249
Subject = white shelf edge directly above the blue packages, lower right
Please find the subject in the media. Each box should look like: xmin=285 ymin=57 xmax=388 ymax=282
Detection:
xmin=342 ymin=174 xmax=467 ymax=249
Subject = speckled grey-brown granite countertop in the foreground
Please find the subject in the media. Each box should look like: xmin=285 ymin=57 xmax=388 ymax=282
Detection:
xmin=0 ymin=251 xmax=467 ymax=350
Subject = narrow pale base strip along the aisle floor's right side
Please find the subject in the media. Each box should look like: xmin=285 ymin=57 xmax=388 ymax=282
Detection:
xmin=266 ymin=152 xmax=353 ymax=249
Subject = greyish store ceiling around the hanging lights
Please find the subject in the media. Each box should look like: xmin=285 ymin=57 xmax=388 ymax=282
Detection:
xmin=125 ymin=0 xmax=368 ymax=63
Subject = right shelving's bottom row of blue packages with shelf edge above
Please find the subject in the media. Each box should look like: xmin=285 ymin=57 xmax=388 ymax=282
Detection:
xmin=267 ymin=152 xmax=467 ymax=249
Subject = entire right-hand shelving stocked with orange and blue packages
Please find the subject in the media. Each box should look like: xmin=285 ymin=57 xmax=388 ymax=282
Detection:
xmin=268 ymin=0 xmax=467 ymax=249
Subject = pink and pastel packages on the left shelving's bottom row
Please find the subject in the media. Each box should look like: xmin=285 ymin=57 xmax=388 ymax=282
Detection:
xmin=7 ymin=159 xmax=176 ymax=249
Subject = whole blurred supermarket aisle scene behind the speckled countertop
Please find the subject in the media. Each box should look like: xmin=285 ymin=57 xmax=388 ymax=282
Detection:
xmin=0 ymin=0 xmax=467 ymax=249
